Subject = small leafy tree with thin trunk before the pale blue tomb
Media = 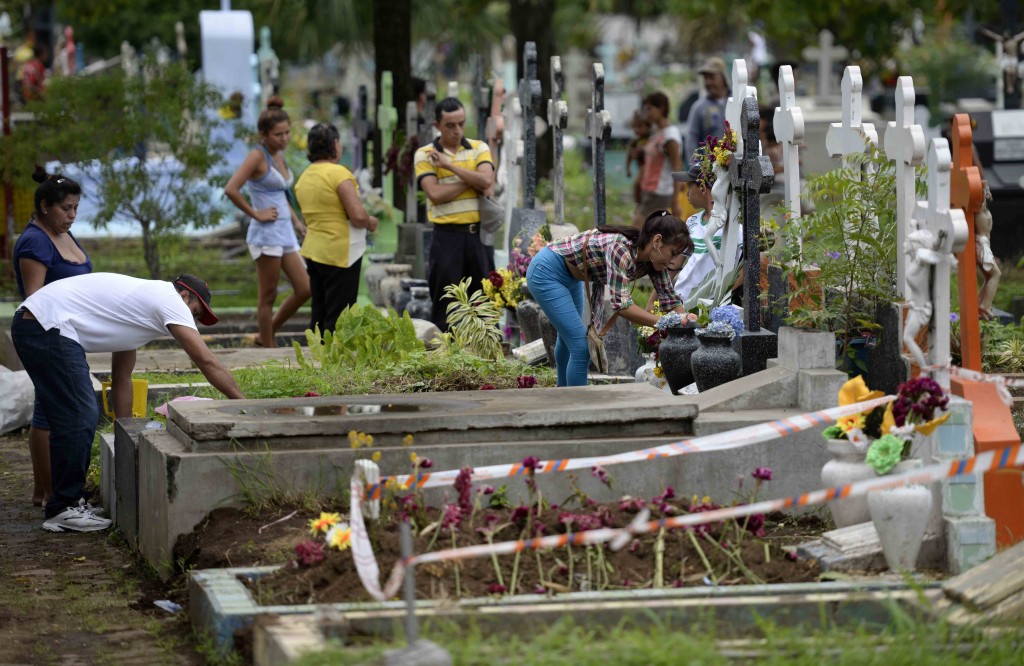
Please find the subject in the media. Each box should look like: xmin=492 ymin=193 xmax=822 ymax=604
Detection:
xmin=0 ymin=55 xmax=228 ymax=279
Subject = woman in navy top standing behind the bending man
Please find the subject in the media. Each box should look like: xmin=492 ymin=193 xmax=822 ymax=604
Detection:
xmin=13 ymin=166 xmax=92 ymax=506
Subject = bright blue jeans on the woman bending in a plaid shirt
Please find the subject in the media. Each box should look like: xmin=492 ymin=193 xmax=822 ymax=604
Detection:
xmin=526 ymin=248 xmax=590 ymax=386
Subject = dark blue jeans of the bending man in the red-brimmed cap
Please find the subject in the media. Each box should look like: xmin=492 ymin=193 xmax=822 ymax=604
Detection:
xmin=10 ymin=310 xmax=99 ymax=518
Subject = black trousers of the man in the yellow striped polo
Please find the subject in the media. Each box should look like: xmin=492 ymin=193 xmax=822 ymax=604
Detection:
xmin=427 ymin=224 xmax=494 ymax=332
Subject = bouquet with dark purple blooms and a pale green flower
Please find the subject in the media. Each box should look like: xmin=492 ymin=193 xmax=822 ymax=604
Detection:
xmin=864 ymin=377 xmax=949 ymax=474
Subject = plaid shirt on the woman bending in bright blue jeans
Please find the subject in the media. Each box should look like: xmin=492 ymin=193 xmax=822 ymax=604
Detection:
xmin=548 ymin=231 xmax=683 ymax=328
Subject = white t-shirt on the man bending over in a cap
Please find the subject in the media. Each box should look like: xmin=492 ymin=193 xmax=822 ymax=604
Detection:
xmin=22 ymin=273 xmax=198 ymax=351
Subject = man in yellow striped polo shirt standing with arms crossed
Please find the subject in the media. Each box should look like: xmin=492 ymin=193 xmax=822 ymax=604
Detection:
xmin=415 ymin=97 xmax=495 ymax=331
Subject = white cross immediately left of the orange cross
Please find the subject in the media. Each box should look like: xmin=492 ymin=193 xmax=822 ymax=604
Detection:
xmin=908 ymin=138 xmax=968 ymax=390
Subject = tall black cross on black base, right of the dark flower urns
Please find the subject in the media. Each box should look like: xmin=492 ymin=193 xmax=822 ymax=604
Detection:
xmin=723 ymin=96 xmax=778 ymax=376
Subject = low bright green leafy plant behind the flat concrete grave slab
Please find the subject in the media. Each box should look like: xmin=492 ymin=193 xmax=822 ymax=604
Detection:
xmin=292 ymin=303 xmax=424 ymax=369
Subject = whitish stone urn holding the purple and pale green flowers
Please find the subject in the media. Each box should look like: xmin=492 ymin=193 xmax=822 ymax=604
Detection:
xmin=867 ymin=458 xmax=933 ymax=572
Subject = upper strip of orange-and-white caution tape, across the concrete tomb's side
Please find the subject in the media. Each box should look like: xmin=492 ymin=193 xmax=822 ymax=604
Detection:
xmin=364 ymin=396 xmax=896 ymax=500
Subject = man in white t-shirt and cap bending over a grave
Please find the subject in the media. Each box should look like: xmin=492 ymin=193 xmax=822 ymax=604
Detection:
xmin=11 ymin=273 xmax=245 ymax=532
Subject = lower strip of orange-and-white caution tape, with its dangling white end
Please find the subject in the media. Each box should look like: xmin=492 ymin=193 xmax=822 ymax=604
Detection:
xmin=350 ymin=445 xmax=1024 ymax=600
